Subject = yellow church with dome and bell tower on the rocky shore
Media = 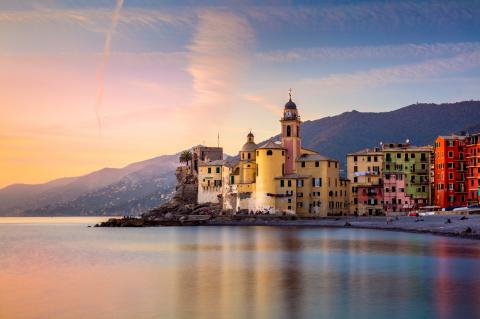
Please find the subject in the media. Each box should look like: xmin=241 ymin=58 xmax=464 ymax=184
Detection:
xmin=197 ymin=93 xmax=349 ymax=216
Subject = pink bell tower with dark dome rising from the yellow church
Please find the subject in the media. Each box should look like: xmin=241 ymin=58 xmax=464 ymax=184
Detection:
xmin=280 ymin=89 xmax=302 ymax=174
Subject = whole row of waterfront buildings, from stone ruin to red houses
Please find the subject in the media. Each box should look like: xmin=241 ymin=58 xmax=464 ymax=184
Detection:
xmin=189 ymin=96 xmax=480 ymax=216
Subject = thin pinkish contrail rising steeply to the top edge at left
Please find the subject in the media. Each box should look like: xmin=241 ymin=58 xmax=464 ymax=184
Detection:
xmin=95 ymin=0 xmax=123 ymax=136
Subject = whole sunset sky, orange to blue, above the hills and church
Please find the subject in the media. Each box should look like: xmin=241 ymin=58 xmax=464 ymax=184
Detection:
xmin=0 ymin=0 xmax=480 ymax=187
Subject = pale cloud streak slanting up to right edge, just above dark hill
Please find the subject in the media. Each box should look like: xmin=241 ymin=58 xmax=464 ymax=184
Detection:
xmin=301 ymin=51 xmax=480 ymax=91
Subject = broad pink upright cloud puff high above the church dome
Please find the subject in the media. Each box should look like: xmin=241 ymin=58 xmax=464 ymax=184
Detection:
xmin=188 ymin=10 xmax=255 ymax=114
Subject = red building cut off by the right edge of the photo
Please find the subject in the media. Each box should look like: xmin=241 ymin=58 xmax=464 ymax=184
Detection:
xmin=465 ymin=133 xmax=480 ymax=205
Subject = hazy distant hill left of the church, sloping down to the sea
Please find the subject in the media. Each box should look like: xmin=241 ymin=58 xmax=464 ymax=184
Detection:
xmin=0 ymin=154 xmax=178 ymax=215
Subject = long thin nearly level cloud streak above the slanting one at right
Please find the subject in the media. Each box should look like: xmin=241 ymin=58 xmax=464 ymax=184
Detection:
xmin=256 ymin=42 xmax=480 ymax=62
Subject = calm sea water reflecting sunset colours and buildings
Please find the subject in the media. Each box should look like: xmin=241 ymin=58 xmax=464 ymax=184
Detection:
xmin=0 ymin=218 xmax=480 ymax=319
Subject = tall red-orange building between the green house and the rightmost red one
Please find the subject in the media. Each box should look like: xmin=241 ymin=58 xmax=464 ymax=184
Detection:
xmin=434 ymin=135 xmax=466 ymax=208
